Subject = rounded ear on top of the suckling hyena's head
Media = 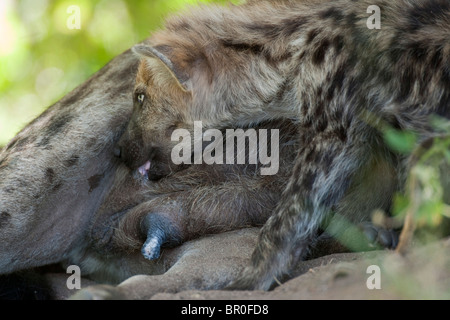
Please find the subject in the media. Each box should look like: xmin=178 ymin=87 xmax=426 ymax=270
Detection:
xmin=132 ymin=44 xmax=192 ymax=91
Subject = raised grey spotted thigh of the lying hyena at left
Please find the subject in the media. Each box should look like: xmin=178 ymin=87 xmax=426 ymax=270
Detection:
xmin=0 ymin=48 xmax=137 ymax=274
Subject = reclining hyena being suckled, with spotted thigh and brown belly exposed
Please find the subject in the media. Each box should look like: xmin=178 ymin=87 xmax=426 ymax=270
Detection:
xmin=0 ymin=42 xmax=298 ymax=298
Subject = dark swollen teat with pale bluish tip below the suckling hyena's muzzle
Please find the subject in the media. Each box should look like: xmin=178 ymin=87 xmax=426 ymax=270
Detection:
xmin=141 ymin=213 xmax=181 ymax=260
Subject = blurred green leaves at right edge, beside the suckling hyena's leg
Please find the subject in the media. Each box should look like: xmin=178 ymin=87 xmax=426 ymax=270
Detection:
xmin=327 ymin=117 xmax=450 ymax=251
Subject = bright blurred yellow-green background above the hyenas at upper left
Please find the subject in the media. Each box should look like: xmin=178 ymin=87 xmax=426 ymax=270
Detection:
xmin=0 ymin=0 xmax=239 ymax=146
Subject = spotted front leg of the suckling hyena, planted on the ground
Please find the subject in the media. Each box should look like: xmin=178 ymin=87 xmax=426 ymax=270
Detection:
xmin=229 ymin=129 xmax=370 ymax=290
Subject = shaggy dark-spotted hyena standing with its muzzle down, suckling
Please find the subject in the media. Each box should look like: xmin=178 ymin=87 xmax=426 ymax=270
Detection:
xmin=121 ymin=0 xmax=450 ymax=289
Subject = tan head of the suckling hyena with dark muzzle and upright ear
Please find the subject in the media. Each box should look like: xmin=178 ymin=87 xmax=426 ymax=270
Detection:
xmin=116 ymin=45 xmax=188 ymax=180
